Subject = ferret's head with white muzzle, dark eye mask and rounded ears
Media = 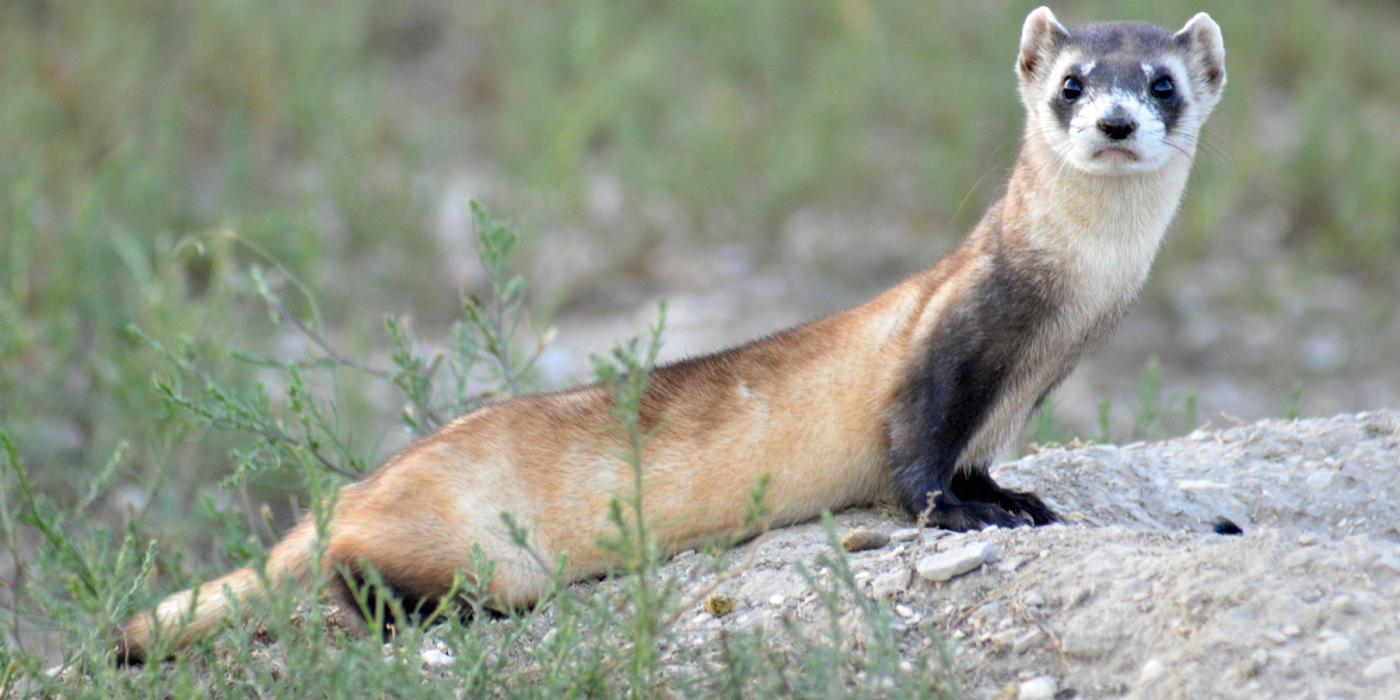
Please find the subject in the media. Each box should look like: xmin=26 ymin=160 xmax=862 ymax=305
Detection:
xmin=1016 ymin=7 xmax=1225 ymax=175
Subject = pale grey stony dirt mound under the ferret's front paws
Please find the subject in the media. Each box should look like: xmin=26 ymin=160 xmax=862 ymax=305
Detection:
xmin=630 ymin=412 xmax=1400 ymax=699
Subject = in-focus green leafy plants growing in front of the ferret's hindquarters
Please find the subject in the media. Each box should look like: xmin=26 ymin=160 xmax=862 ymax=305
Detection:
xmin=0 ymin=202 xmax=955 ymax=697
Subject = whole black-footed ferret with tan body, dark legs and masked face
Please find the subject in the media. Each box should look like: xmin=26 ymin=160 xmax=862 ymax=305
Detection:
xmin=118 ymin=7 xmax=1225 ymax=662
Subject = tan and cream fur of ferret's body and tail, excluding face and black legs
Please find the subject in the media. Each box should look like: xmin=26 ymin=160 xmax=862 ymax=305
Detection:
xmin=120 ymin=8 xmax=1224 ymax=661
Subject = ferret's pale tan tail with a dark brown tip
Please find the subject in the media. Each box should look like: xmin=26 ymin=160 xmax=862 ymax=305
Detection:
xmin=116 ymin=518 xmax=316 ymax=665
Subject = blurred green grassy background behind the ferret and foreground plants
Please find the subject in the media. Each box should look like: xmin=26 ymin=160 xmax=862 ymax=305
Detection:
xmin=0 ymin=0 xmax=1400 ymax=607
